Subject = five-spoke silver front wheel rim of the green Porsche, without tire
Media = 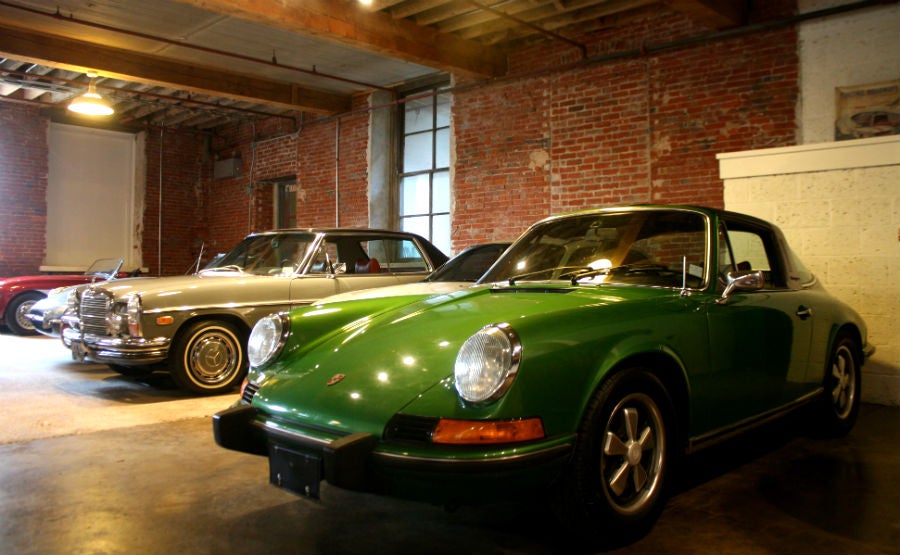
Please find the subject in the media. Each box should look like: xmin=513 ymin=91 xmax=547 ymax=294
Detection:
xmin=601 ymin=394 xmax=665 ymax=514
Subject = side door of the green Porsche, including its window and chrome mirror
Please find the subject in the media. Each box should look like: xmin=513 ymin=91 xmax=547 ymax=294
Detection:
xmin=694 ymin=220 xmax=813 ymax=432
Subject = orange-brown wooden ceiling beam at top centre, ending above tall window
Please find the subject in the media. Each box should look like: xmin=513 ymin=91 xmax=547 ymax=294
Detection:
xmin=170 ymin=0 xmax=507 ymax=77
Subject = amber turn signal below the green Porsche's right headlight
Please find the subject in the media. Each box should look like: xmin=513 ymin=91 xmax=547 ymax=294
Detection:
xmin=431 ymin=418 xmax=544 ymax=445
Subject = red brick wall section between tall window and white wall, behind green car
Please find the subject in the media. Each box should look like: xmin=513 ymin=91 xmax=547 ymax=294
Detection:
xmin=453 ymin=1 xmax=798 ymax=251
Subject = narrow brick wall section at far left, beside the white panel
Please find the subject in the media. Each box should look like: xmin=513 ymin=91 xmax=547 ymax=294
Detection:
xmin=0 ymin=103 xmax=49 ymax=277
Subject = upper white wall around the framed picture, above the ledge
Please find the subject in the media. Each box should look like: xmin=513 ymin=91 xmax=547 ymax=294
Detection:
xmin=798 ymin=0 xmax=900 ymax=144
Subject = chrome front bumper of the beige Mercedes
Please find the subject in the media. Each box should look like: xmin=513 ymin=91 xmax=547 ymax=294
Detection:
xmin=62 ymin=327 xmax=172 ymax=366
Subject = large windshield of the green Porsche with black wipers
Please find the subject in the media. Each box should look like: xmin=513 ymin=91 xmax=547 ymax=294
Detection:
xmin=479 ymin=209 xmax=708 ymax=287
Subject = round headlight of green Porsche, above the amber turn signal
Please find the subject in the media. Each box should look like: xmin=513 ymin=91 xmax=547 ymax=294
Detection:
xmin=453 ymin=324 xmax=522 ymax=403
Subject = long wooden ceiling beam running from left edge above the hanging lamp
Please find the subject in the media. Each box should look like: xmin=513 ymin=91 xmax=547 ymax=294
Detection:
xmin=0 ymin=22 xmax=351 ymax=114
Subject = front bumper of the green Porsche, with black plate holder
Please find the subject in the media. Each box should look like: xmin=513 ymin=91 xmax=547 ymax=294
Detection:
xmin=213 ymin=404 xmax=574 ymax=503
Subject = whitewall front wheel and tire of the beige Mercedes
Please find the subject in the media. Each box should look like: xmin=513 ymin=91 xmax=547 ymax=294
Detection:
xmin=169 ymin=320 xmax=247 ymax=395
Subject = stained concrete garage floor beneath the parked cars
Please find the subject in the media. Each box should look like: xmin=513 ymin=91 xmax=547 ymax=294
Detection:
xmin=0 ymin=334 xmax=900 ymax=555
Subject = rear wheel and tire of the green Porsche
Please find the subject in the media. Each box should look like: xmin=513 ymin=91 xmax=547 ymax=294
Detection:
xmin=820 ymin=336 xmax=862 ymax=437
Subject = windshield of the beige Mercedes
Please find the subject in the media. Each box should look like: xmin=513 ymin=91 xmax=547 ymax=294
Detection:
xmin=200 ymin=233 xmax=316 ymax=276
